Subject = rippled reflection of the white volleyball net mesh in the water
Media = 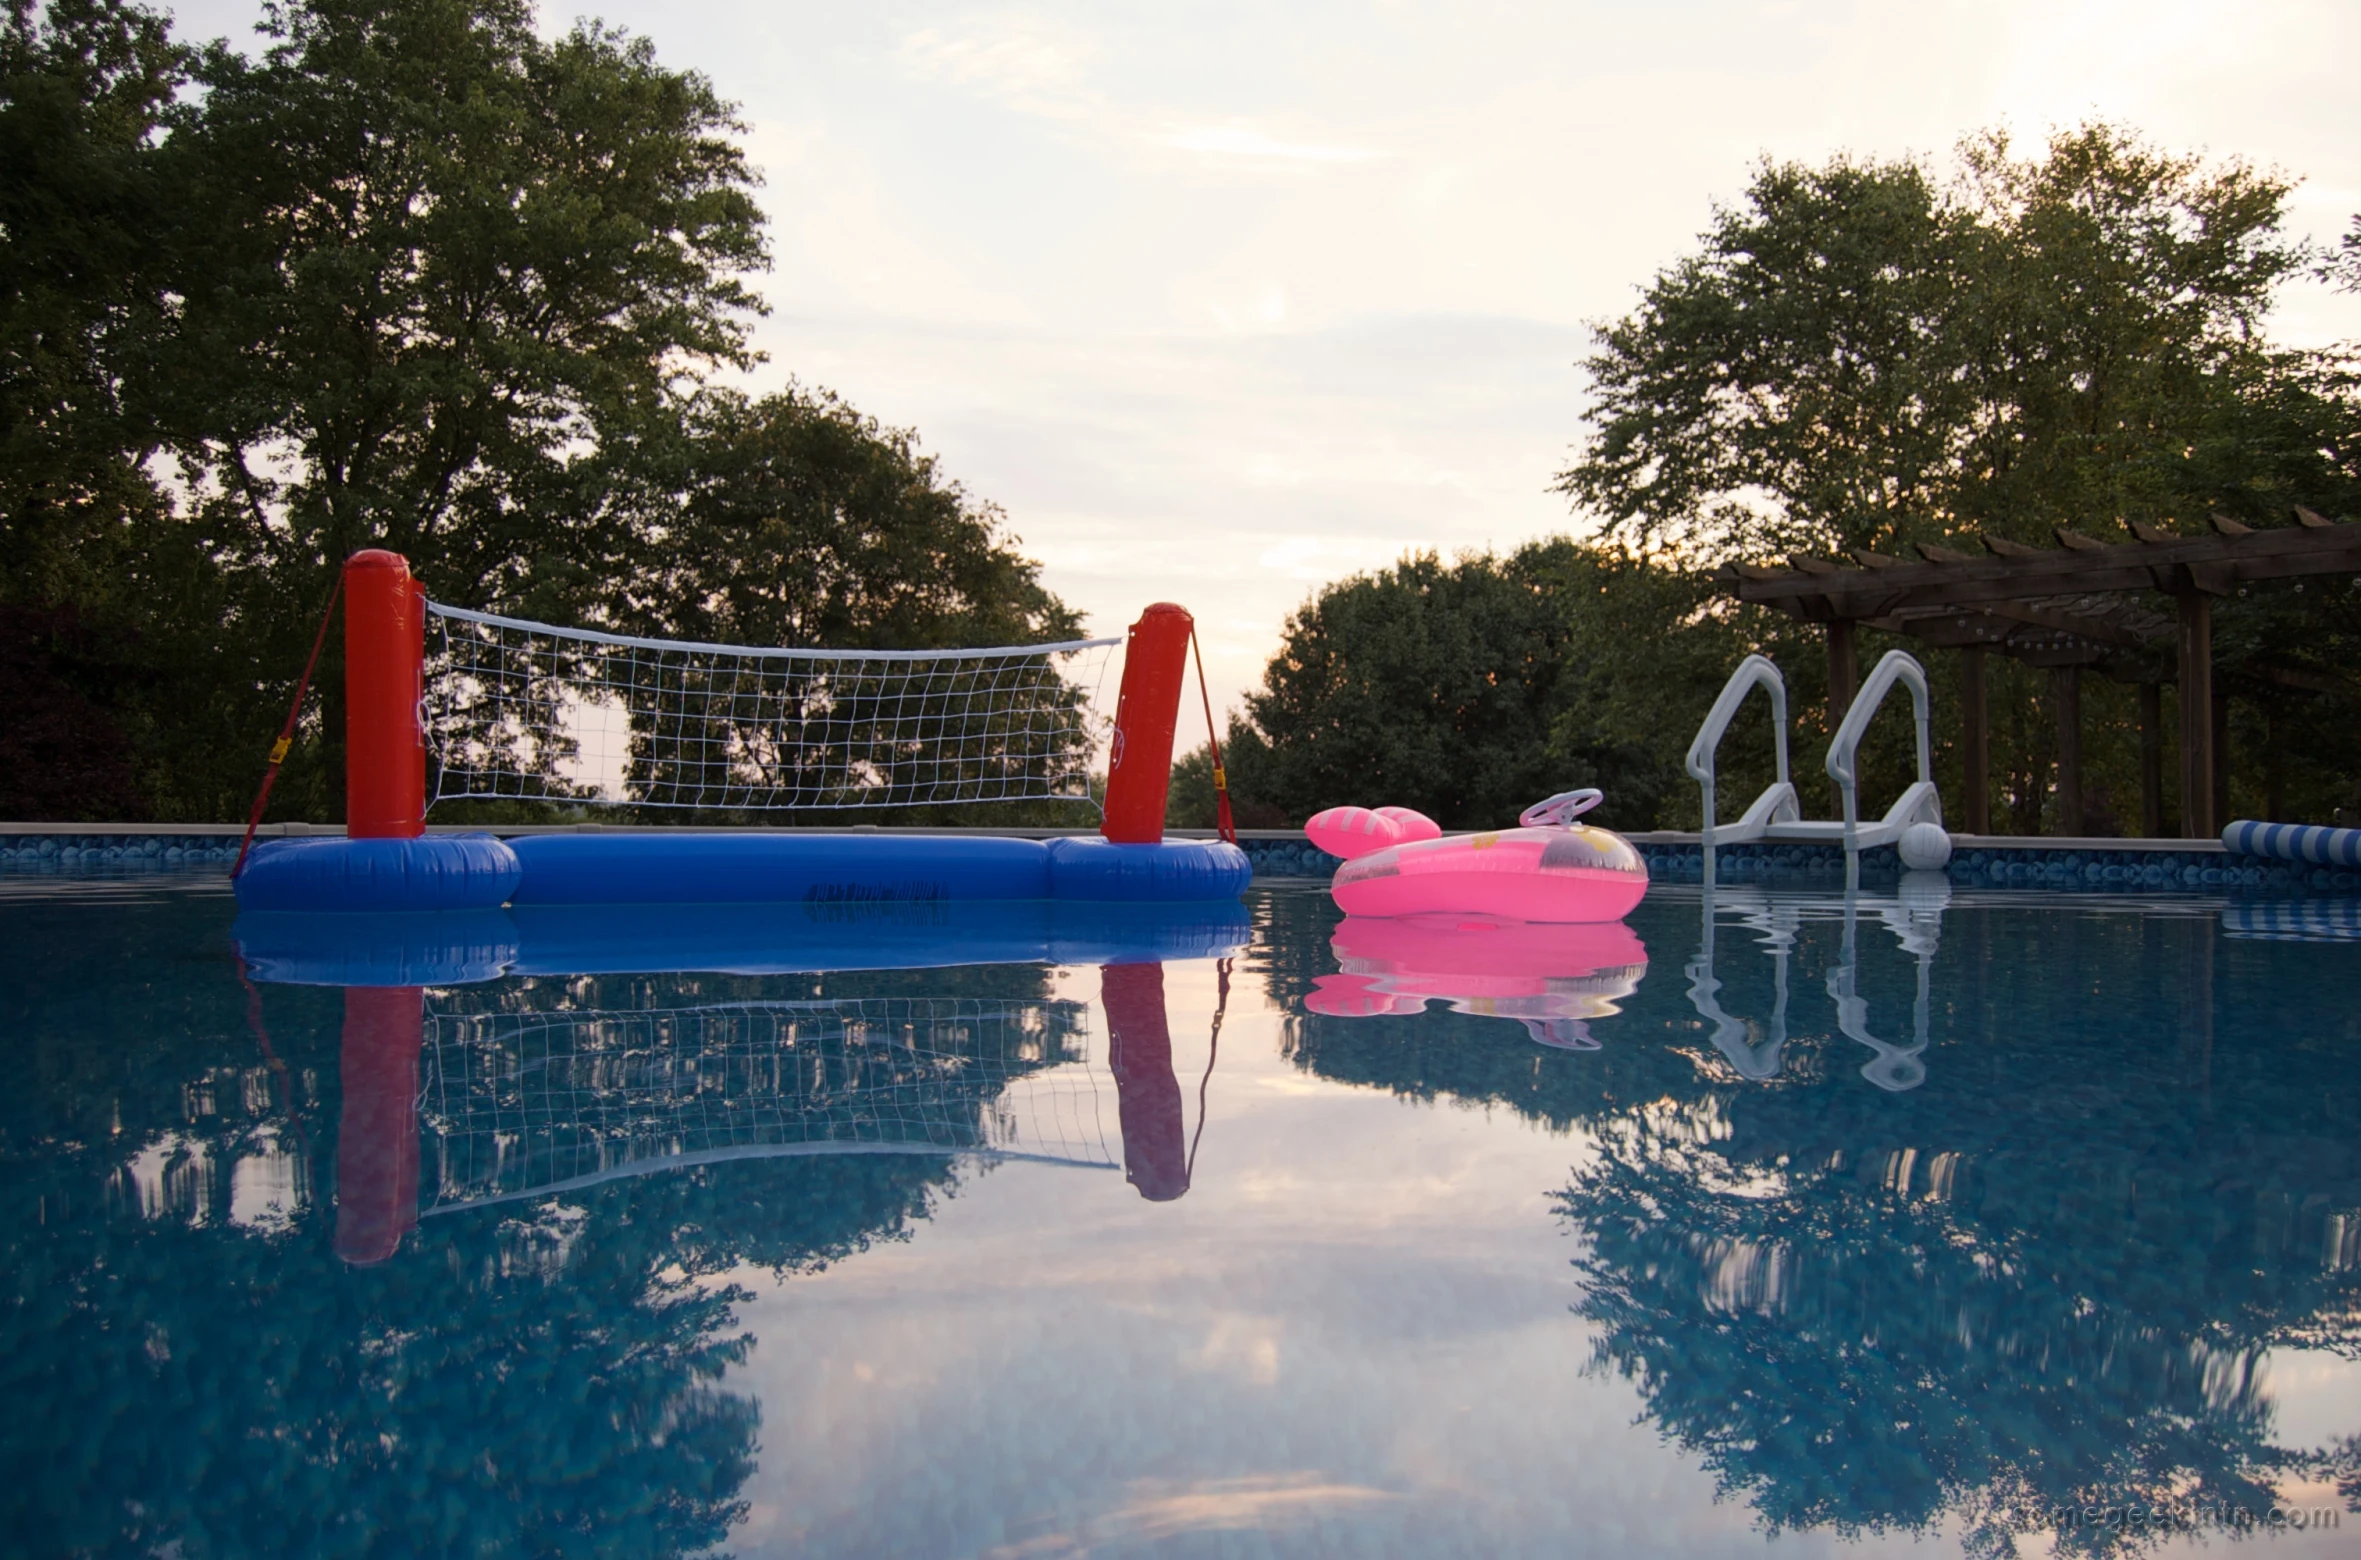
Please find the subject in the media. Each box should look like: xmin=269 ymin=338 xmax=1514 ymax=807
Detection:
xmin=418 ymin=996 xmax=1119 ymax=1208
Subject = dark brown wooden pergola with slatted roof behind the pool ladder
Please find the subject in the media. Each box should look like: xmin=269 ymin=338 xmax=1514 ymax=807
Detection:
xmin=1719 ymin=510 xmax=2361 ymax=840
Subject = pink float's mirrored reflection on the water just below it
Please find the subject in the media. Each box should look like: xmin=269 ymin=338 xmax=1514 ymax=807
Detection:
xmin=1303 ymin=913 xmax=1648 ymax=1050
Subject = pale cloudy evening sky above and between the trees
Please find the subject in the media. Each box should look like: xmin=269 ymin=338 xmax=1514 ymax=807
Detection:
xmin=177 ymin=0 xmax=2361 ymax=743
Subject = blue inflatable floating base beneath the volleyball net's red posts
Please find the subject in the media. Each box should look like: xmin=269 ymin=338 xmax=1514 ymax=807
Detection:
xmin=238 ymin=831 xmax=1254 ymax=913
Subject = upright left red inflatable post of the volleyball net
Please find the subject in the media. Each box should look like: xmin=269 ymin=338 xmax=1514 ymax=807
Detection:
xmin=345 ymin=548 xmax=427 ymax=840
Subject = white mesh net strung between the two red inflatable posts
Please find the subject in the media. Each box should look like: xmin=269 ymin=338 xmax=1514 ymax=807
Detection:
xmin=423 ymin=602 xmax=1121 ymax=812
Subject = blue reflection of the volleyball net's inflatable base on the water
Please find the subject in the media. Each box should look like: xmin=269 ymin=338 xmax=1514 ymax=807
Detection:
xmin=234 ymin=899 xmax=1251 ymax=987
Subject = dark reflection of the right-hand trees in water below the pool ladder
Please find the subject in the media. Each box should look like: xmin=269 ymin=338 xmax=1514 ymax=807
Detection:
xmin=1261 ymin=885 xmax=2361 ymax=1555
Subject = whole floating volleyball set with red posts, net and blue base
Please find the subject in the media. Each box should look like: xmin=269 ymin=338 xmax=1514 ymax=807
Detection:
xmin=229 ymin=548 xmax=1251 ymax=913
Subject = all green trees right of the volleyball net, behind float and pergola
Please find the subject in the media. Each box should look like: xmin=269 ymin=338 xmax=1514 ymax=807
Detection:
xmin=1176 ymin=123 xmax=2361 ymax=833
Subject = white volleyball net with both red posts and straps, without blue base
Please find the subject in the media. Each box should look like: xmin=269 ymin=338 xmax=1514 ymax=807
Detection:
xmin=258 ymin=548 xmax=1228 ymax=840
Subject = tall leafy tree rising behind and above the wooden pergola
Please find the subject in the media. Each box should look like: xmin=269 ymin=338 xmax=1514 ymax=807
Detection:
xmin=1558 ymin=125 xmax=2361 ymax=833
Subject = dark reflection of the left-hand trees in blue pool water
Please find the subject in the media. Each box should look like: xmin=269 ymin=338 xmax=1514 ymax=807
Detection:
xmin=0 ymin=887 xmax=1071 ymax=1558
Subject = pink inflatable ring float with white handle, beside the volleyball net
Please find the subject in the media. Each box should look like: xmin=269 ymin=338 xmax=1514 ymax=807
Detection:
xmin=1303 ymin=791 xmax=1648 ymax=920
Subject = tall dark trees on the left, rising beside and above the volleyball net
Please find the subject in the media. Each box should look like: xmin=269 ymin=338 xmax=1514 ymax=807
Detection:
xmin=0 ymin=0 xmax=1077 ymax=819
